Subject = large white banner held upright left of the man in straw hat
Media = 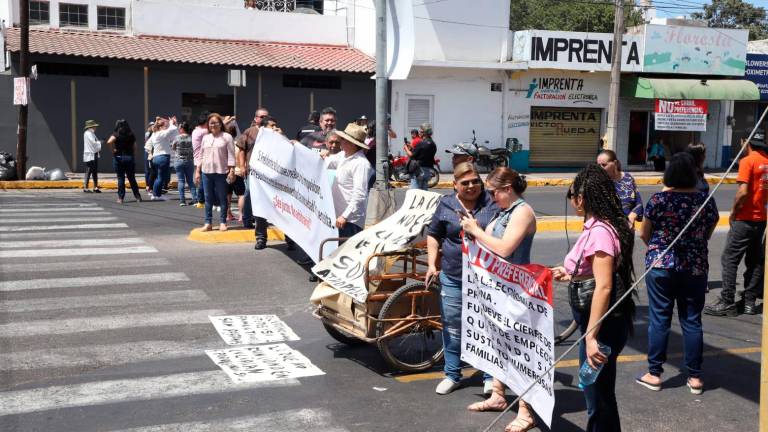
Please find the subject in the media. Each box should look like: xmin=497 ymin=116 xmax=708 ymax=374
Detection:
xmin=248 ymin=128 xmax=339 ymax=259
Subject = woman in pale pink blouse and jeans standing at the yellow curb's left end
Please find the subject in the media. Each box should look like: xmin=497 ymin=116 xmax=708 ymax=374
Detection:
xmin=195 ymin=113 xmax=235 ymax=231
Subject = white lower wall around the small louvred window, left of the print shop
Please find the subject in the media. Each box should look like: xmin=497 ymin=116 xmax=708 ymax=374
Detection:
xmin=390 ymin=67 xmax=504 ymax=170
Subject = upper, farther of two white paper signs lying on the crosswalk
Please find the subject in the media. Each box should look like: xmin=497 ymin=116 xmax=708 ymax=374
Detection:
xmin=208 ymin=315 xmax=300 ymax=345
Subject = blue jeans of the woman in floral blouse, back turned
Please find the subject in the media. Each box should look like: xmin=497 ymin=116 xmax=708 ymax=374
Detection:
xmin=645 ymin=269 xmax=707 ymax=378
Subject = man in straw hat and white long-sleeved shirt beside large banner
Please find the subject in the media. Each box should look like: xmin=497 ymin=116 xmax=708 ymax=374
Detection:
xmin=321 ymin=123 xmax=372 ymax=237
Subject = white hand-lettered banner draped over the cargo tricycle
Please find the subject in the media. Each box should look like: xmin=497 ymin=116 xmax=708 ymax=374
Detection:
xmin=312 ymin=189 xmax=441 ymax=303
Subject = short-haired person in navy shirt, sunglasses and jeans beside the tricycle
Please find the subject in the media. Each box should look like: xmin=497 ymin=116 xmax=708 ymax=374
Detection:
xmin=425 ymin=163 xmax=499 ymax=395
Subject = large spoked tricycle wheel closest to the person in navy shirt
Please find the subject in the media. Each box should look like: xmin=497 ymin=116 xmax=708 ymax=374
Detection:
xmin=376 ymin=282 xmax=443 ymax=372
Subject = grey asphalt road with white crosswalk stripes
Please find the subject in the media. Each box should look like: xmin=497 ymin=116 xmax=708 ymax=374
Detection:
xmin=0 ymin=188 xmax=761 ymax=432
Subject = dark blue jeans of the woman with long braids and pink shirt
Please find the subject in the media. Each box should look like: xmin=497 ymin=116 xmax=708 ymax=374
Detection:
xmin=573 ymin=310 xmax=630 ymax=432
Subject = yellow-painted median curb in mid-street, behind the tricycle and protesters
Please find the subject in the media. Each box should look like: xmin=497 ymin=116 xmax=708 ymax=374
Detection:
xmin=187 ymin=212 xmax=730 ymax=244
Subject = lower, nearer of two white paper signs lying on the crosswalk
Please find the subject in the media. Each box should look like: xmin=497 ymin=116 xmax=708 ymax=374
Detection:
xmin=205 ymin=344 xmax=325 ymax=384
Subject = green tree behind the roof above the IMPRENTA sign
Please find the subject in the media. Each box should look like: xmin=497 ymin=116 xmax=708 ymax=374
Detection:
xmin=509 ymin=0 xmax=644 ymax=33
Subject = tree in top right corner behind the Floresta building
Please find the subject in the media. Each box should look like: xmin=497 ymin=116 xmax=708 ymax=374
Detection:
xmin=691 ymin=0 xmax=768 ymax=40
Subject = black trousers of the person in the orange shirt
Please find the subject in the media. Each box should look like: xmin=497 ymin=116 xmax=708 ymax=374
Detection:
xmin=720 ymin=221 xmax=765 ymax=303
